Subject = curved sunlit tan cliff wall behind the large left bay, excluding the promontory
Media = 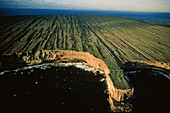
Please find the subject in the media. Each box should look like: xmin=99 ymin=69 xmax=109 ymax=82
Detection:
xmin=1 ymin=50 xmax=110 ymax=74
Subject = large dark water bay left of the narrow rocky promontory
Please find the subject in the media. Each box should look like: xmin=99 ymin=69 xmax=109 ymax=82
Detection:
xmin=0 ymin=64 xmax=109 ymax=113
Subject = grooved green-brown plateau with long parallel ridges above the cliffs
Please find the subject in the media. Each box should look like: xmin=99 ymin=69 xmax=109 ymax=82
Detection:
xmin=0 ymin=15 xmax=170 ymax=76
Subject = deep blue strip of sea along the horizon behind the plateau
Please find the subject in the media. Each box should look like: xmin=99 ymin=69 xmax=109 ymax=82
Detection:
xmin=0 ymin=8 xmax=170 ymax=19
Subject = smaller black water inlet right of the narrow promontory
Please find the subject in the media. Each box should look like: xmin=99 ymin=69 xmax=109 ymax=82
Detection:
xmin=125 ymin=69 xmax=170 ymax=112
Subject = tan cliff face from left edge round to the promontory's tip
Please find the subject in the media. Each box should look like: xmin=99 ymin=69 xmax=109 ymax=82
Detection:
xmin=0 ymin=50 xmax=134 ymax=111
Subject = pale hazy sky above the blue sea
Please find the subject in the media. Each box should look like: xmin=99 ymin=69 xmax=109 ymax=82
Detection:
xmin=0 ymin=0 xmax=170 ymax=12
